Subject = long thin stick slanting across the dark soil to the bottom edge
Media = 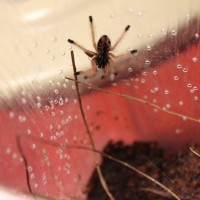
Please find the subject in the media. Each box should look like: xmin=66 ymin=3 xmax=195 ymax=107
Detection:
xmin=18 ymin=135 xmax=181 ymax=200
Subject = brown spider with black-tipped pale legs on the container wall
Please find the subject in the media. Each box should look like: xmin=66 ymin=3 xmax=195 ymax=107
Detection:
xmin=68 ymin=16 xmax=137 ymax=79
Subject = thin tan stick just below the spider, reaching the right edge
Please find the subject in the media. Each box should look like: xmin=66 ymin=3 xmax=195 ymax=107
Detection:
xmin=65 ymin=77 xmax=200 ymax=123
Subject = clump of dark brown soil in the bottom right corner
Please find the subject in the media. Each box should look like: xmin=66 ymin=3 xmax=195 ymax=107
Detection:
xmin=88 ymin=142 xmax=200 ymax=200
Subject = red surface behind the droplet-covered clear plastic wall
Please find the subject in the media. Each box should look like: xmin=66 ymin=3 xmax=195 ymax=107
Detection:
xmin=0 ymin=42 xmax=200 ymax=199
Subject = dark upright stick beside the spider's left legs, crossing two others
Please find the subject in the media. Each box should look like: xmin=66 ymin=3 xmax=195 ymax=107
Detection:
xmin=71 ymin=51 xmax=115 ymax=200
